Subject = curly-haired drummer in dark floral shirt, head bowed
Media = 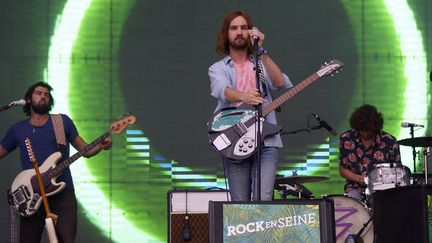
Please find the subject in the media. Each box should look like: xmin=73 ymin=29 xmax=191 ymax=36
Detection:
xmin=339 ymin=104 xmax=401 ymax=201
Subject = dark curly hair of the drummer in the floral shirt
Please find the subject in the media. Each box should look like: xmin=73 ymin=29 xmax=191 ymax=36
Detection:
xmin=350 ymin=104 xmax=384 ymax=134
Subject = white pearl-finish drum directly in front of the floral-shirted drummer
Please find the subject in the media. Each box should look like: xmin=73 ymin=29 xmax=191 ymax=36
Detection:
xmin=365 ymin=163 xmax=411 ymax=195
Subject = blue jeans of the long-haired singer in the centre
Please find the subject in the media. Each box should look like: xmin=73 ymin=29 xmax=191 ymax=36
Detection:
xmin=222 ymin=147 xmax=278 ymax=201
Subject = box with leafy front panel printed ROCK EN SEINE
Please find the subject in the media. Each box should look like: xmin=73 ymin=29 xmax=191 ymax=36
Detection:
xmin=209 ymin=199 xmax=336 ymax=243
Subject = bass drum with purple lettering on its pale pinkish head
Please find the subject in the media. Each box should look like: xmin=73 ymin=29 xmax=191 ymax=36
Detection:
xmin=327 ymin=195 xmax=373 ymax=243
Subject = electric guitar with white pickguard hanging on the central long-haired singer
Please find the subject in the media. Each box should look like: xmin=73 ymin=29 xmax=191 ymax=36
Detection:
xmin=208 ymin=59 xmax=343 ymax=161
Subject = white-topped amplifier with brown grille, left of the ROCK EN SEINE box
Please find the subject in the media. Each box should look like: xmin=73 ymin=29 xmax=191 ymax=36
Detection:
xmin=168 ymin=190 xmax=230 ymax=243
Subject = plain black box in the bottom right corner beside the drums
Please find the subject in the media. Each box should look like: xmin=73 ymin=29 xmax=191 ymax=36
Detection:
xmin=373 ymin=185 xmax=432 ymax=242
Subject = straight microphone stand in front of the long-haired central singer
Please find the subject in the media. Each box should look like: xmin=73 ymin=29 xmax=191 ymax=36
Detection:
xmin=254 ymin=38 xmax=262 ymax=201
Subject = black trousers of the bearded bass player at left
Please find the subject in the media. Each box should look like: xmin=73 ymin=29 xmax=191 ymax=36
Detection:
xmin=20 ymin=189 xmax=77 ymax=243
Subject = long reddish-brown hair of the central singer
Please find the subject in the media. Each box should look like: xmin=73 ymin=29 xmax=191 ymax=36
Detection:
xmin=216 ymin=11 xmax=253 ymax=55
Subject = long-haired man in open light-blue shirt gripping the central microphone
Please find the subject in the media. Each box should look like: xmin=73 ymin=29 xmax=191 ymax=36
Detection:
xmin=208 ymin=11 xmax=292 ymax=201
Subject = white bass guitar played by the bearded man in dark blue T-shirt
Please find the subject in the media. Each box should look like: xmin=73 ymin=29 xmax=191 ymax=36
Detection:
xmin=8 ymin=116 xmax=136 ymax=217
